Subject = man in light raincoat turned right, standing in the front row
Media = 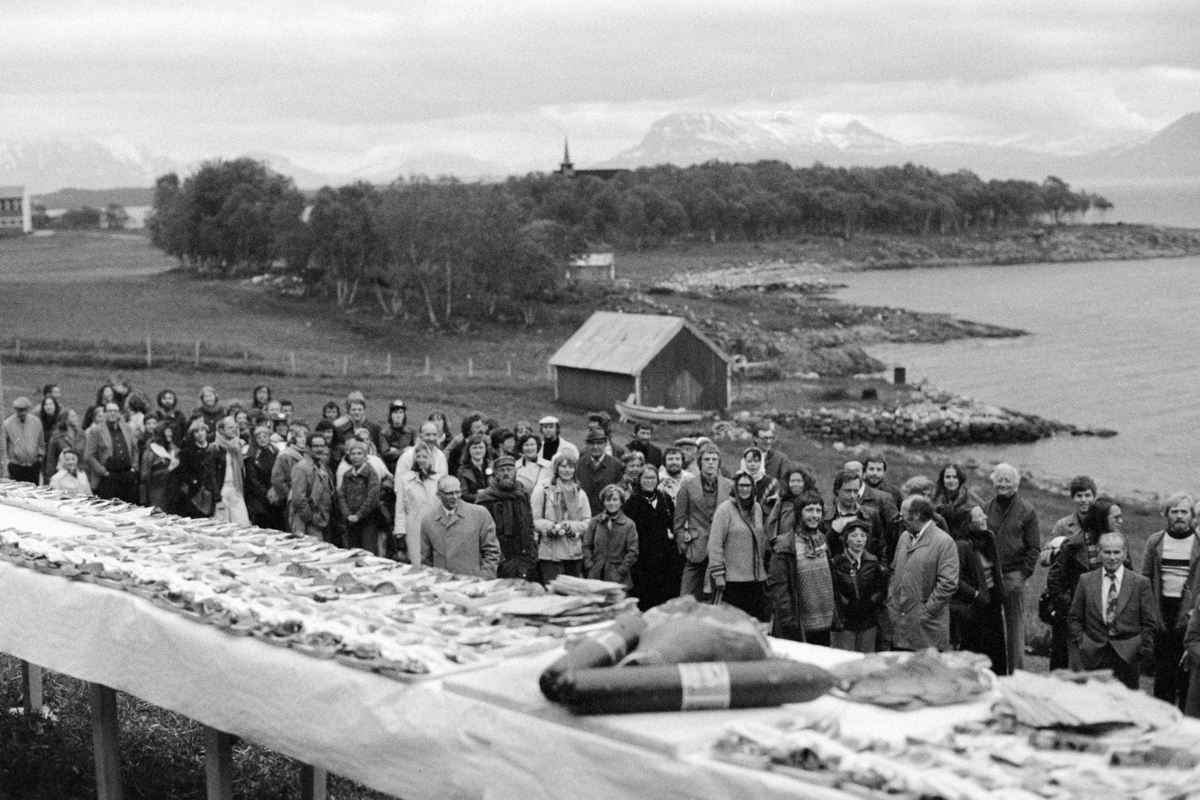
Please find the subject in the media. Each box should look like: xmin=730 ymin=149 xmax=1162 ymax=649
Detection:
xmin=888 ymin=494 xmax=959 ymax=650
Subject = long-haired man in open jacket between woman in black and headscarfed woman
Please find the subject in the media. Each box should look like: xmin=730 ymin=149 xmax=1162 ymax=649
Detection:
xmin=673 ymin=445 xmax=733 ymax=600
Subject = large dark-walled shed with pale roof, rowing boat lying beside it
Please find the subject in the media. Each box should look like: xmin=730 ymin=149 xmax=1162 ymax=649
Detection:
xmin=550 ymin=311 xmax=732 ymax=411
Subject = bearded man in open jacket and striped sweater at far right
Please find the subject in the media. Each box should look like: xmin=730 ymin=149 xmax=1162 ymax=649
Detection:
xmin=1141 ymin=492 xmax=1200 ymax=709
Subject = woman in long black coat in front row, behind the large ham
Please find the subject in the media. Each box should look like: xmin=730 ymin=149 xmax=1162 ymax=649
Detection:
xmin=623 ymin=464 xmax=683 ymax=610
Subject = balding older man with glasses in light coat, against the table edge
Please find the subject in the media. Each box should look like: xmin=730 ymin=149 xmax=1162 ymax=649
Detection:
xmin=421 ymin=475 xmax=500 ymax=578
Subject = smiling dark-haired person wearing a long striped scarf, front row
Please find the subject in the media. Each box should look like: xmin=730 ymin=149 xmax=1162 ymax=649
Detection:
xmin=767 ymin=492 xmax=835 ymax=646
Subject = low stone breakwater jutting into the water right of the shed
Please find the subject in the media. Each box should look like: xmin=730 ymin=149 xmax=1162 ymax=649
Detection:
xmin=724 ymin=386 xmax=1116 ymax=447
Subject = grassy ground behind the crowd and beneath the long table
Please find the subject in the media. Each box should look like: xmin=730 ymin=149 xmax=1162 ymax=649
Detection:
xmin=0 ymin=227 xmax=1160 ymax=800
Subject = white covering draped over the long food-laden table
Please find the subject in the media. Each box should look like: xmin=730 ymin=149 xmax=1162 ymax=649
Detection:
xmin=0 ymin=505 xmax=979 ymax=800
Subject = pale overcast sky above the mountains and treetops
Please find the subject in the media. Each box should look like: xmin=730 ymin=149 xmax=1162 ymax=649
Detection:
xmin=0 ymin=0 xmax=1200 ymax=169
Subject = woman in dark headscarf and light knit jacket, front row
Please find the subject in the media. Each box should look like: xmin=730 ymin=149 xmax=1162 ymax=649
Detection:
xmin=708 ymin=471 xmax=769 ymax=622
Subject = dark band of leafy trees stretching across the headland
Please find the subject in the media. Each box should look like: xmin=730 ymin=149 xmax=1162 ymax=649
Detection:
xmin=146 ymin=158 xmax=1111 ymax=327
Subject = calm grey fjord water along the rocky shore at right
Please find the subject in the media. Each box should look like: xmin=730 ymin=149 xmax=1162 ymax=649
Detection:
xmin=838 ymin=253 xmax=1200 ymax=494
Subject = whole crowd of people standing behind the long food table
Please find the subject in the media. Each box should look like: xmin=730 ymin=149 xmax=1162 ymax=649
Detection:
xmin=0 ymin=381 xmax=1200 ymax=716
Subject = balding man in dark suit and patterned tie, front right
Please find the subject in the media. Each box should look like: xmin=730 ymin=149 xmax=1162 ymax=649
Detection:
xmin=1067 ymin=533 xmax=1159 ymax=690
